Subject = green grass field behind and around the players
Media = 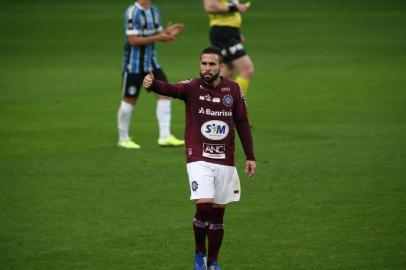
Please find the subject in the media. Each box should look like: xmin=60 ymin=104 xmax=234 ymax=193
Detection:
xmin=0 ymin=0 xmax=406 ymax=270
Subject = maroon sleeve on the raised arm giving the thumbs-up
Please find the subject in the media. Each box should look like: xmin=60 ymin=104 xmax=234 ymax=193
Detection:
xmin=149 ymin=80 xmax=192 ymax=101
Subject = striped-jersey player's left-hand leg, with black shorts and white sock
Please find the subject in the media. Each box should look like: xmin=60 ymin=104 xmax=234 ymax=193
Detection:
xmin=117 ymin=73 xmax=141 ymax=149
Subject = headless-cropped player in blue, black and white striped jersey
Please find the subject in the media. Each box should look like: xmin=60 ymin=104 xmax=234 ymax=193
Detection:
xmin=117 ymin=0 xmax=184 ymax=149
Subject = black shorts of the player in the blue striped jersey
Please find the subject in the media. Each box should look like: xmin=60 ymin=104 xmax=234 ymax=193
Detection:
xmin=122 ymin=68 xmax=168 ymax=98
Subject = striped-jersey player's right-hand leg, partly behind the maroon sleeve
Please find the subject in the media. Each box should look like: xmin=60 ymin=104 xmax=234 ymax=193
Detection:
xmin=154 ymin=69 xmax=185 ymax=146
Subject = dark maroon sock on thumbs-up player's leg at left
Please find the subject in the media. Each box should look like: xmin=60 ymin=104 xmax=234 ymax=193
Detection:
xmin=193 ymin=203 xmax=213 ymax=253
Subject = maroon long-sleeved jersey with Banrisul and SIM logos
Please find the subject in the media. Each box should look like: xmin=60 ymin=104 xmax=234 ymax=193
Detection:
xmin=150 ymin=77 xmax=255 ymax=166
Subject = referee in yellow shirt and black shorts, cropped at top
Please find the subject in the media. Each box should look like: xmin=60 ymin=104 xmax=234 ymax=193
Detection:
xmin=204 ymin=0 xmax=254 ymax=96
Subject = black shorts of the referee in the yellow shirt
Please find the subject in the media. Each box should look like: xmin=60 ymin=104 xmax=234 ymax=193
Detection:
xmin=210 ymin=26 xmax=247 ymax=63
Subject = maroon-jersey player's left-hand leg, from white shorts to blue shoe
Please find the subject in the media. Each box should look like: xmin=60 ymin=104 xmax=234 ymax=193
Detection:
xmin=187 ymin=161 xmax=214 ymax=270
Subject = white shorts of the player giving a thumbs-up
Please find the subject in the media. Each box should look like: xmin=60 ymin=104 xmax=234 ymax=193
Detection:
xmin=186 ymin=161 xmax=241 ymax=204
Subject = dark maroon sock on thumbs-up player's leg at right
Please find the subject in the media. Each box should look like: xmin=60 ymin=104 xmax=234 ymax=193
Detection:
xmin=207 ymin=208 xmax=225 ymax=261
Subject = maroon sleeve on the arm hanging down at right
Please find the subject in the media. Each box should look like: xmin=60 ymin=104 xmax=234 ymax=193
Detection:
xmin=233 ymin=86 xmax=255 ymax=160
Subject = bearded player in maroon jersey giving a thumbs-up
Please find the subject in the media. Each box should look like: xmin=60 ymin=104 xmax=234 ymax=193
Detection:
xmin=143 ymin=47 xmax=256 ymax=270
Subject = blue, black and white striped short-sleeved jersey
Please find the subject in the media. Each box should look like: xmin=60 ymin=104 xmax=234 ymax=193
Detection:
xmin=123 ymin=3 xmax=162 ymax=73
